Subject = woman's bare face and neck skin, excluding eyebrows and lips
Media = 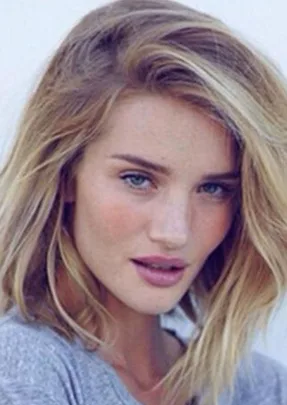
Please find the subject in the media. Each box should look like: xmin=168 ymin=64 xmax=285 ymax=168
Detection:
xmin=69 ymin=94 xmax=237 ymax=405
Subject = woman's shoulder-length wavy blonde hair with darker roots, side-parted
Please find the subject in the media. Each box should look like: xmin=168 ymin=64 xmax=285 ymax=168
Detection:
xmin=0 ymin=0 xmax=287 ymax=404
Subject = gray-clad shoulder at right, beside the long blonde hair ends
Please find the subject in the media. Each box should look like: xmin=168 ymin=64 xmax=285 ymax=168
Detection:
xmin=226 ymin=352 xmax=287 ymax=405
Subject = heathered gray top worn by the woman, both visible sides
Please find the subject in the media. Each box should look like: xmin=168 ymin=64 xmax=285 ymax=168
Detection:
xmin=0 ymin=314 xmax=287 ymax=405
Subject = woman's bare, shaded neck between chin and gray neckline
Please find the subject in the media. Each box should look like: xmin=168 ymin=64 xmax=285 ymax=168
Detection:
xmin=99 ymin=297 xmax=180 ymax=389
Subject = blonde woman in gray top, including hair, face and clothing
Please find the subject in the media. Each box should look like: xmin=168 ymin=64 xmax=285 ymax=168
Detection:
xmin=0 ymin=0 xmax=287 ymax=405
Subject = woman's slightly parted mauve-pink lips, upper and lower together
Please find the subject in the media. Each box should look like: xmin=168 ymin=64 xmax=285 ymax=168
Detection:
xmin=131 ymin=257 xmax=187 ymax=287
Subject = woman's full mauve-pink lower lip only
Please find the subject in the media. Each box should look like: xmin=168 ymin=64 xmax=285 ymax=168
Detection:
xmin=133 ymin=262 xmax=184 ymax=287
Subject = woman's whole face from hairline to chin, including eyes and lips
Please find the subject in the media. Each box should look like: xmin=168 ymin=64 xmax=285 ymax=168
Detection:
xmin=73 ymin=95 xmax=238 ymax=314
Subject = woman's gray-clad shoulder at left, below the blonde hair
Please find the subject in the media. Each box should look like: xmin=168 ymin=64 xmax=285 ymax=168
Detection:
xmin=0 ymin=313 xmax=126 ymax=405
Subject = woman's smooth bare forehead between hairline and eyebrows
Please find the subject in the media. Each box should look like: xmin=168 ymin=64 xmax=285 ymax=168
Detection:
xmin=88 ymin=94 xmax=234 ymax=174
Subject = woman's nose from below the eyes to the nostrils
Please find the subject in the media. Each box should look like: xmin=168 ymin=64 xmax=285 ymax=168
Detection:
xmin=149 ymin=196 xmax=190 ymax=250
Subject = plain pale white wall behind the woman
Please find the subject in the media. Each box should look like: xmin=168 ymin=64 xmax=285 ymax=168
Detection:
xmin=0 ymin=0 xmax=287 ymax=365
